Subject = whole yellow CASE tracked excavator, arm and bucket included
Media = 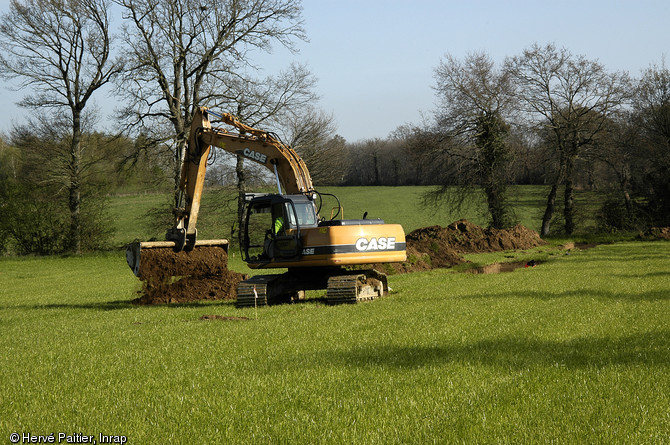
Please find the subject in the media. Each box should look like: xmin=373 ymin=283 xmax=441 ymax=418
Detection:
xmin=126 ymin=107 xmax=406 ymax=307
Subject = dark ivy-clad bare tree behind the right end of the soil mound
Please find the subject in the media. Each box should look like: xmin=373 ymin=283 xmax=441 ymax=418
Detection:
xmin=435 ymin=53 xmax=514 ymax=228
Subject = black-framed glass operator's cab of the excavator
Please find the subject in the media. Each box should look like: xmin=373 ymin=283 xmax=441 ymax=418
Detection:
xmin=241 ymin=195 xmax=318 ymax=262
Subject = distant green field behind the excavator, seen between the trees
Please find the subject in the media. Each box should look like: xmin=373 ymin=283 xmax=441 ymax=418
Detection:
xmin=101 ymin=182 xmax=595 ymax=247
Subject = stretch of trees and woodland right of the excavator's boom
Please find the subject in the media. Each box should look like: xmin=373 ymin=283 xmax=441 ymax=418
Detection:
xmin=318 ymin=44 xmax=670 ymax=236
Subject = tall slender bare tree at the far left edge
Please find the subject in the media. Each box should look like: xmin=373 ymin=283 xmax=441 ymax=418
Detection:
xmin=0 ymin=0 xmax=123 ymax=253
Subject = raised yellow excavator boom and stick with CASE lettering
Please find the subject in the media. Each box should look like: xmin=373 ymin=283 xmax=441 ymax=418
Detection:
xmin=167 ymin=107 xmax=314 ymax=250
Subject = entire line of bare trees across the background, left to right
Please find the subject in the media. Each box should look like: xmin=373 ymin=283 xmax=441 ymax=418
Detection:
xmin=0 ymin=0 xmax=670 ymax=254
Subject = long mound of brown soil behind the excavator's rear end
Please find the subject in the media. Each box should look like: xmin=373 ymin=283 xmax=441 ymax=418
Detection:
xmin=377 ymin=219 xmax=546 ymax=273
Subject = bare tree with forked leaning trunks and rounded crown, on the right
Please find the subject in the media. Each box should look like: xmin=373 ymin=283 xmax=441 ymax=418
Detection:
xmin=508 ymin=44 xmax=629 ymax=236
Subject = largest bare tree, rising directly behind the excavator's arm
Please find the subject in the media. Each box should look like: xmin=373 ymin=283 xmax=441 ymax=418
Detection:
xmin=115 ymin=0 xmax=305 ymax=203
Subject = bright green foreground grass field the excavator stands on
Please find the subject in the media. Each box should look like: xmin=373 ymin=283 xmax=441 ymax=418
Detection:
xmin=0 ymin=186 xmax=670 ymax=444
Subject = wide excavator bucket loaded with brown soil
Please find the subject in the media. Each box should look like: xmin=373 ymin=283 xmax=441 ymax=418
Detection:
xmin=126 ymin=239 xmax=228 ymax=281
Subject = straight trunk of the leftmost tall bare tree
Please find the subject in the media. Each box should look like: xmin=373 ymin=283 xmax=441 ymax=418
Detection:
xmin=68 ymin=110 xmax=81 ymax=254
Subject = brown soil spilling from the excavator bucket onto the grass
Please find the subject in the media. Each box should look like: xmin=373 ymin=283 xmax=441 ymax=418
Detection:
xmin=132 ymin=247 xmax=246 ymax=304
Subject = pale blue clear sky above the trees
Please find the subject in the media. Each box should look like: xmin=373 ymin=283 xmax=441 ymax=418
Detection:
xmin=0 ymin=0 xmax=670 ymax=142
